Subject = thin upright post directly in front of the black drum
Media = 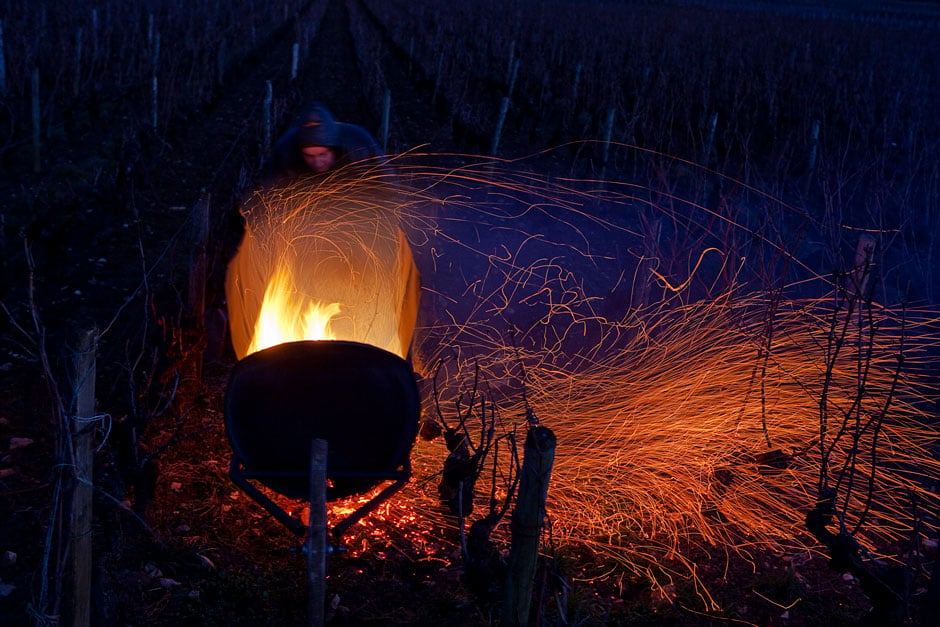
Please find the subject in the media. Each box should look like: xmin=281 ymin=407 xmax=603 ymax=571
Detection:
xmin=307 ymin=438 xmax=327 ymax=627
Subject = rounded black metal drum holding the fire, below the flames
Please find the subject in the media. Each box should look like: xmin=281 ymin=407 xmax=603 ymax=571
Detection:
xmin=225 ymin=340 xmax=420 ymax=500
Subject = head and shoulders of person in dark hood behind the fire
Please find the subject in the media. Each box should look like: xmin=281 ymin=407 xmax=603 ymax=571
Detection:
xmin=262 ymin=102 xmax=382 ymax=183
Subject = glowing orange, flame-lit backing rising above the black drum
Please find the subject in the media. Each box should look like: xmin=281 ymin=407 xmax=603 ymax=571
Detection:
xmin=225 ymin=179 xmax=421 ymax=359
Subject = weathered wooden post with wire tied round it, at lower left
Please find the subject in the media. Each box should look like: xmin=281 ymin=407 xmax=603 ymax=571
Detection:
xmin=67 ymin=329 xmax=98 ymax=626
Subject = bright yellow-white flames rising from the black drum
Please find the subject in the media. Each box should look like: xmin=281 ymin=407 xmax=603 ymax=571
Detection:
xmin=248 ymin=265 xmax=340 ymax=353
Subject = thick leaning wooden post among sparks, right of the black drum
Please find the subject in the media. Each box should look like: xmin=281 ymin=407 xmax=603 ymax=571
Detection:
xmin=503 ymin=426 xmax=556 ymax=625
